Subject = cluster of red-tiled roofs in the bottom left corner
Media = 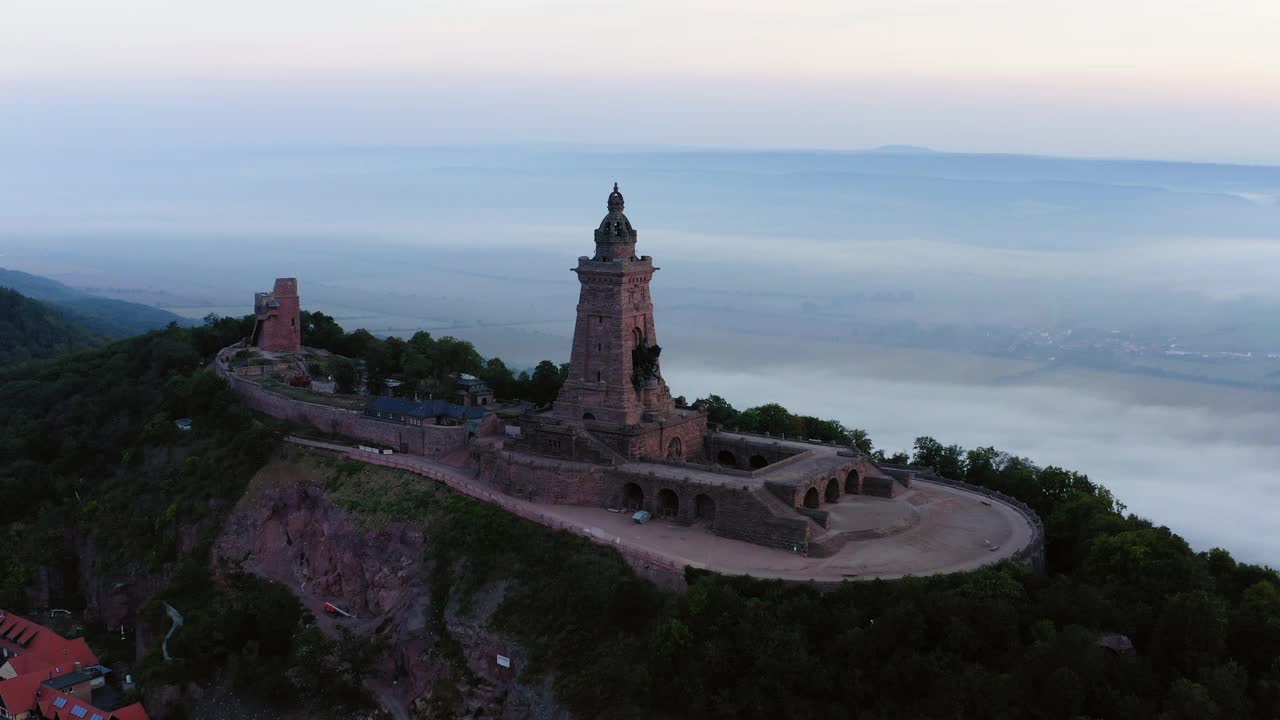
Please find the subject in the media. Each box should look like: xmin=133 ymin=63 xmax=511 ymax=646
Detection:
xmin=0 ymin=610 xmax=148 ymax=720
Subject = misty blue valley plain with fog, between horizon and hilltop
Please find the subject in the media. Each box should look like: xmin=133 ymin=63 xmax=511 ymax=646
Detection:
xmin=0 ymin=149 xmax=1280 ymax=564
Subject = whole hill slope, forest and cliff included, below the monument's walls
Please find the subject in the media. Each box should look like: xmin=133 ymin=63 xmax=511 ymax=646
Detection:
xmin=0 ymin=320 xmax=1280 ymax=719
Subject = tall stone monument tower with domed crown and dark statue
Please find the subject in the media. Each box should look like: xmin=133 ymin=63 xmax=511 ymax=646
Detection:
xmin=550 ymin=183 xmax=707 ymax=459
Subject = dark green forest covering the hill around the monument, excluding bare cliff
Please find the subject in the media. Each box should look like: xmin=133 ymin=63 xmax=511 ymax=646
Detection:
xmin=0 ymin=319 xmax=1280 ymax=720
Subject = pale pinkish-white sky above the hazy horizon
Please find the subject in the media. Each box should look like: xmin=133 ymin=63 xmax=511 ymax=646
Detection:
xmin=0 ymin=0 xmax=1280 ymax=163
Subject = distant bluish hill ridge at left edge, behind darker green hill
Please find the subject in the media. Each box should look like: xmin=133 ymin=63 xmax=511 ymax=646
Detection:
xmin=0 ymin=268 xmax=192 ymax=338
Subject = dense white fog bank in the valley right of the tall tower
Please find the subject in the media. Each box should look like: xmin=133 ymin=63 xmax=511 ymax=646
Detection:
xmin=666 ymin=356 xmax=1280 ymax=565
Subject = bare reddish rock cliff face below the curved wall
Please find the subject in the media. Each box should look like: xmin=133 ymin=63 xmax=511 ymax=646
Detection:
xmin=215 ymin=460 xmax=568 ymax=720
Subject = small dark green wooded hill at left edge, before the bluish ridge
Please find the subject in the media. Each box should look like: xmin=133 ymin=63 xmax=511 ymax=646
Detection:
xmin=0 ymin=287 xmax=105 ymax=366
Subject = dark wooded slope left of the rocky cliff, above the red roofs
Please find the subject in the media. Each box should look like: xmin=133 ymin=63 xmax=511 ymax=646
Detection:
xmin=0 ymin=317 xmax=367 ymax=717
